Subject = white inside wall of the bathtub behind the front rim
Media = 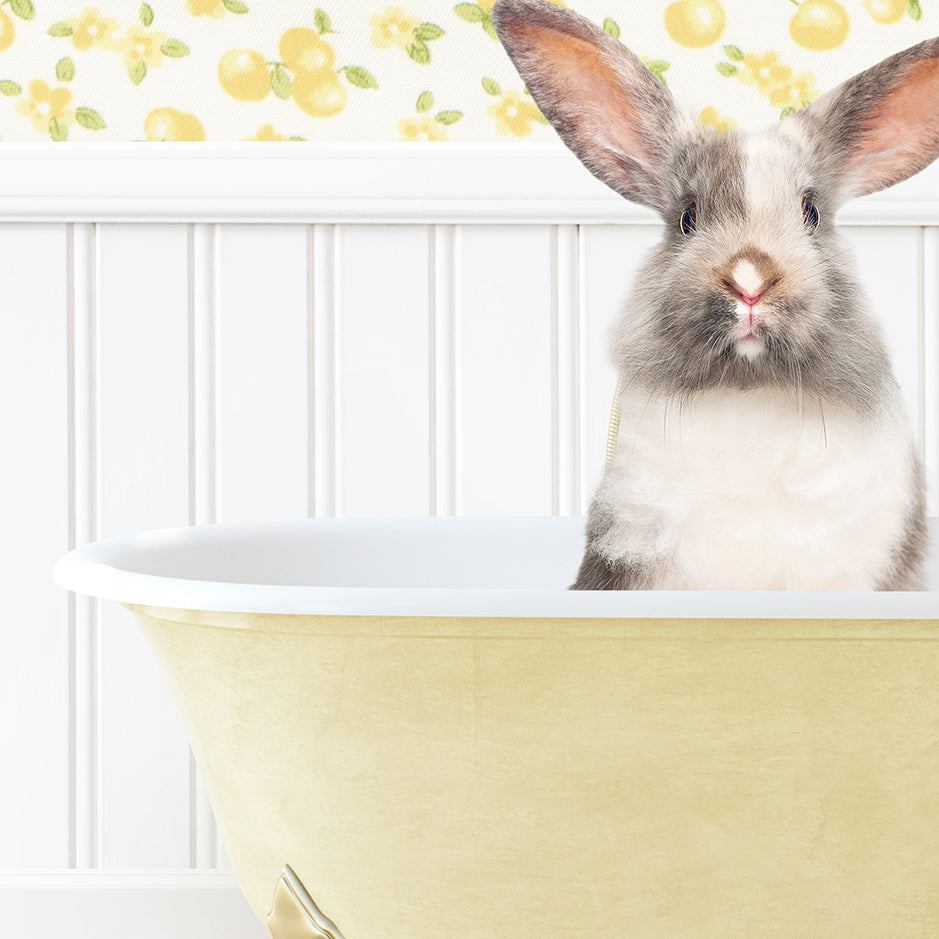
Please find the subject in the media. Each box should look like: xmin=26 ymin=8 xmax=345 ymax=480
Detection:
xmin=82 ymin=516 xmax=939 ymax=591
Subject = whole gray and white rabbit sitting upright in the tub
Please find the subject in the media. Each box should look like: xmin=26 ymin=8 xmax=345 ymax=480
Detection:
xmin=492 ymin=0 xmax=939 ymax=590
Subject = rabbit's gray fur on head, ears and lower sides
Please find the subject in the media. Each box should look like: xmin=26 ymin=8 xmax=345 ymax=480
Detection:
xmin=493 ymin=0 xmax=939 ymax=590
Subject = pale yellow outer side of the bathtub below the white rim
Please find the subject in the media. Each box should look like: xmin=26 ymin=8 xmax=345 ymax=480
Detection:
xmin=130 ymin=618 xmax=939 ymax=939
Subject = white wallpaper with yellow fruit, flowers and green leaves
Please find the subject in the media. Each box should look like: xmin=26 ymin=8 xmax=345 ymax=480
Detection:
xmin=0 ymin=0 xmax=939 ymax=142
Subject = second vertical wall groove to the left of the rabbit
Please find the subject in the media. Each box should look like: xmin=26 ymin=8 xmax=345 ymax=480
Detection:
xmin=429 ymin=225 xmax=459 ymax=515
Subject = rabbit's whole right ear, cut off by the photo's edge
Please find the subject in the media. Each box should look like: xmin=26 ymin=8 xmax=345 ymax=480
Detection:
xmin=796 ymin=39 xmax=939 ymax=201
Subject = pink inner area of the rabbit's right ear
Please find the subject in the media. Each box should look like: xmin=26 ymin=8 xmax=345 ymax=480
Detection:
xmin=847 ymin=58 xmax=939 ymax=195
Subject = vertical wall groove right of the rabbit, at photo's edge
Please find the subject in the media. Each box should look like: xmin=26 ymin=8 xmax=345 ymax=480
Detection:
xmin=921 ymin=227 xmax=939 ymax=515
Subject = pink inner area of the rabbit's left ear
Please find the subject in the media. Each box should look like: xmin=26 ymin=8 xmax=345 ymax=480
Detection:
xmin=517 ymin=23 xmax=650 ymax=163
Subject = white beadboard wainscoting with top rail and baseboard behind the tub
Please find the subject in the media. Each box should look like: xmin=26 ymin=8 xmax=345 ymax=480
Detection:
xmin=0 ymin=144 xmax=939 ymax=939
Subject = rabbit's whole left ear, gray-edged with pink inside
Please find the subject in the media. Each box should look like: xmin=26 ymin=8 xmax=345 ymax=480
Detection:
xmin=492 ymin=0 xmax=695 ymax=210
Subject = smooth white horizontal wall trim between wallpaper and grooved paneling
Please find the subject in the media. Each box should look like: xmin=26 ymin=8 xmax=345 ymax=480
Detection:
xmin=0 ymin=142 xmax=939 ymax=225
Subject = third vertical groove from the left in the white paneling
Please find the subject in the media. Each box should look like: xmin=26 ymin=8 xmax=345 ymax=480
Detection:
xmin=308 ymin=225 xmax=341 ymax=517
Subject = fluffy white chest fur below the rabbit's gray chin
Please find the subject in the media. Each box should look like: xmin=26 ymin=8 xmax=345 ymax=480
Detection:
xmin=593 ymin=390 xmax=914 ymax=589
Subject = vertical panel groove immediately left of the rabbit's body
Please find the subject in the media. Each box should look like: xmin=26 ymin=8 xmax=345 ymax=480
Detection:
xmin=551 ymin=225 xmax=580 ymax=515
